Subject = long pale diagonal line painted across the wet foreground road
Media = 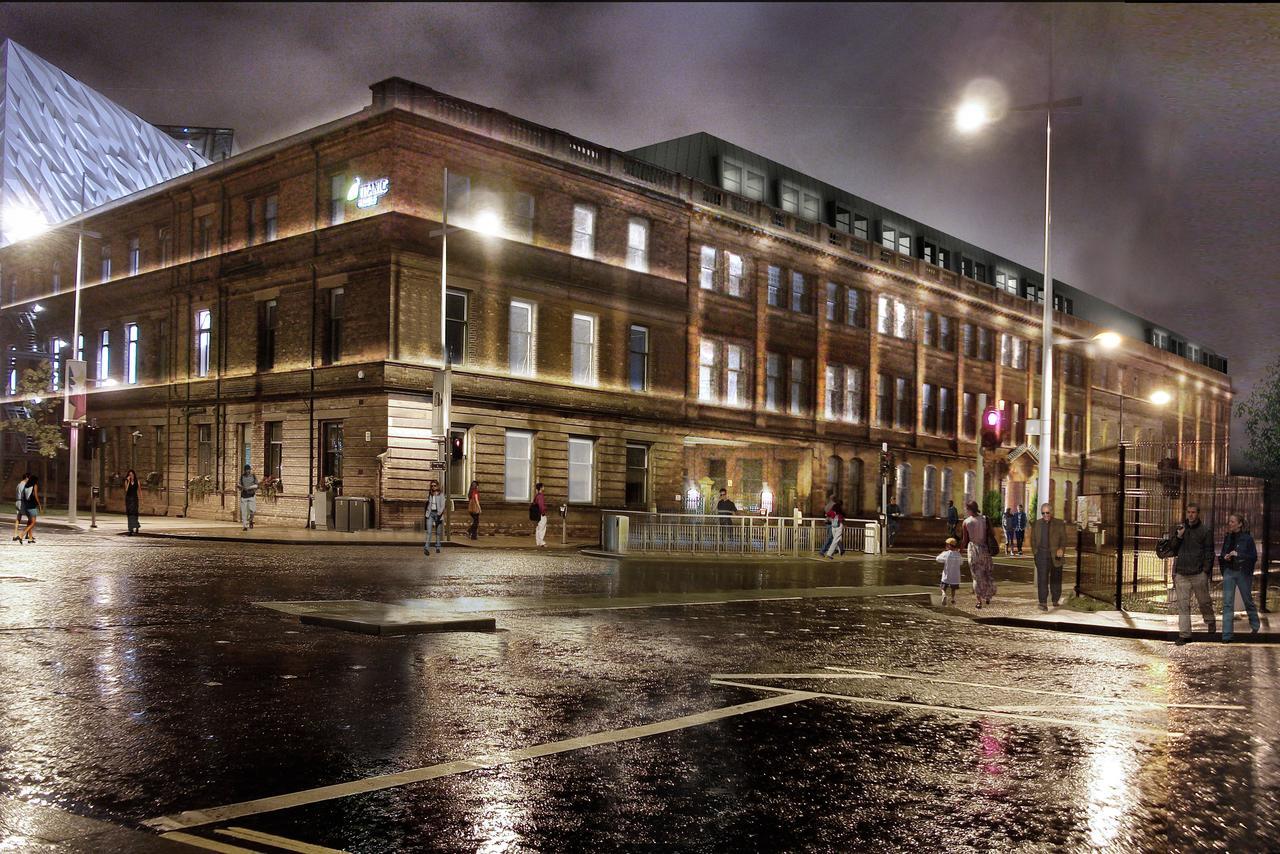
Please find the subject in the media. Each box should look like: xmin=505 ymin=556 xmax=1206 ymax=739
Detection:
xmin=143 ymin=689 xmax=803 ymax=839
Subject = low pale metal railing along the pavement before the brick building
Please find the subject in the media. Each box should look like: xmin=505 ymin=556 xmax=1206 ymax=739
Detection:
xmin=608 ymin=512 xmax=877 ymax=557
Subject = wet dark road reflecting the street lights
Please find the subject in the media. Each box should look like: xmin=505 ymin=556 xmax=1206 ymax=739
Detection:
xmin=0 ymin=534 xmax=1280 ymax=851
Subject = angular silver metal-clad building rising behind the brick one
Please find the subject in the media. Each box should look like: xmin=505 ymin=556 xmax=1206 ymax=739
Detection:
xmin=0 ymin=40 xmax=209 ymax=246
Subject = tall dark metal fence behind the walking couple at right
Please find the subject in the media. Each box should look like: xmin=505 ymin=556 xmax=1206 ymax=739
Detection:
xmin=1076 ymin=442 xmax=1280 ymax=611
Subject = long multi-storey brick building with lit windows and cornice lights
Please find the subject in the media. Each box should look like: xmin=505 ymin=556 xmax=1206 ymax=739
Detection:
xmin=0 ymin=78 xmax=1230 ymax=530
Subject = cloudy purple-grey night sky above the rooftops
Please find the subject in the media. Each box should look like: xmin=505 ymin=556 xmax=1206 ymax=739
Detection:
xmin=0 ymin=4 xmax=1280 ymax=468
